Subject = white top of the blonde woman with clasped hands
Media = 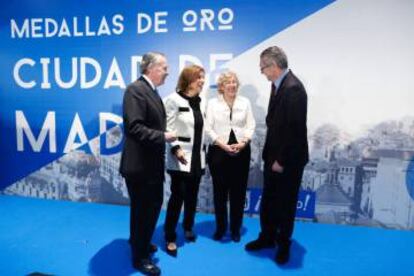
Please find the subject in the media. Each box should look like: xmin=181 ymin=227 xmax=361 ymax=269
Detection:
xmin=205 ymin=95 xmax=256 ymax=144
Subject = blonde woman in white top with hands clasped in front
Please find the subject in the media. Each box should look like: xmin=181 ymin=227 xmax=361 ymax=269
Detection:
xmin=206 ymin=72 xmax=256 ymax=242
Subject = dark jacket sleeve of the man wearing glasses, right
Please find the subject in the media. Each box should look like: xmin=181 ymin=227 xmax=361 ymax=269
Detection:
xmin=276 ymin=86 xmax=307 ymax=166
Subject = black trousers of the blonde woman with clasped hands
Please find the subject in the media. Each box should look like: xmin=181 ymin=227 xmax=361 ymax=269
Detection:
xmin=208 ymin=145 xmax=251 ymax=234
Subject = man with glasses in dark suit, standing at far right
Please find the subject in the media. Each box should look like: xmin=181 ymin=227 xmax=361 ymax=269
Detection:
xmin=246 ymin=46 xmax=309 ymax=264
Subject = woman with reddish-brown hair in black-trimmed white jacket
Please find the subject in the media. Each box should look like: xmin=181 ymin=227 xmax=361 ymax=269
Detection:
xmin=164 ymin=65 xmax=205 ymax=257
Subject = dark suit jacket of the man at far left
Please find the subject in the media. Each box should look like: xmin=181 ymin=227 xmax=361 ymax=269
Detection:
xmin=120 ymin=77 xmax=166 ymax=179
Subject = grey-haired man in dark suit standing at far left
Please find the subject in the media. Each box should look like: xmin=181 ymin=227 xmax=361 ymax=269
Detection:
xmin=120 ymin=52 xmax=175 ymax=275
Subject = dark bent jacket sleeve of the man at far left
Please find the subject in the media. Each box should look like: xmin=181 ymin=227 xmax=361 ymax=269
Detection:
xmin=123 ymin=86 xmax=165 ymax=145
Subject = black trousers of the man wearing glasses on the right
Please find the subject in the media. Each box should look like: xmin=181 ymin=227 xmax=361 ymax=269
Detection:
xmin=260 ymin=164 xmax=304 ymax=246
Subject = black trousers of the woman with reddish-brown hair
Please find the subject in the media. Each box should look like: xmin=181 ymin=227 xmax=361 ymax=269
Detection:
xmin=164 ymin=172 xmax=201 ymax=242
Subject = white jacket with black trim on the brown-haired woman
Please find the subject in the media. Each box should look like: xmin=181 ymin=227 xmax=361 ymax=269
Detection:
xmin=164 ymin=92 xmax=206 ymax=172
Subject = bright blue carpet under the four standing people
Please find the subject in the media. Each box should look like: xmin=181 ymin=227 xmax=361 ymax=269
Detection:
xmin=0 ymin=196 xmax=414 ymax=276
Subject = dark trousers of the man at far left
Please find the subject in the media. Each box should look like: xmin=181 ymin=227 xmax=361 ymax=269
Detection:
xmin=125 ymin=175 xmax=164 ymax=261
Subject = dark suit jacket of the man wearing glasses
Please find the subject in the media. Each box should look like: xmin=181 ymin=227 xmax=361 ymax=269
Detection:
xmin=263 ymin=71 xmax=309 ymax=167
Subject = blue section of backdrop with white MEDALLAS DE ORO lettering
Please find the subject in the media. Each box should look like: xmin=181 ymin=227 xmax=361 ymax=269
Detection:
xmin=0 ymin=0 xmax=332 ymax=192
